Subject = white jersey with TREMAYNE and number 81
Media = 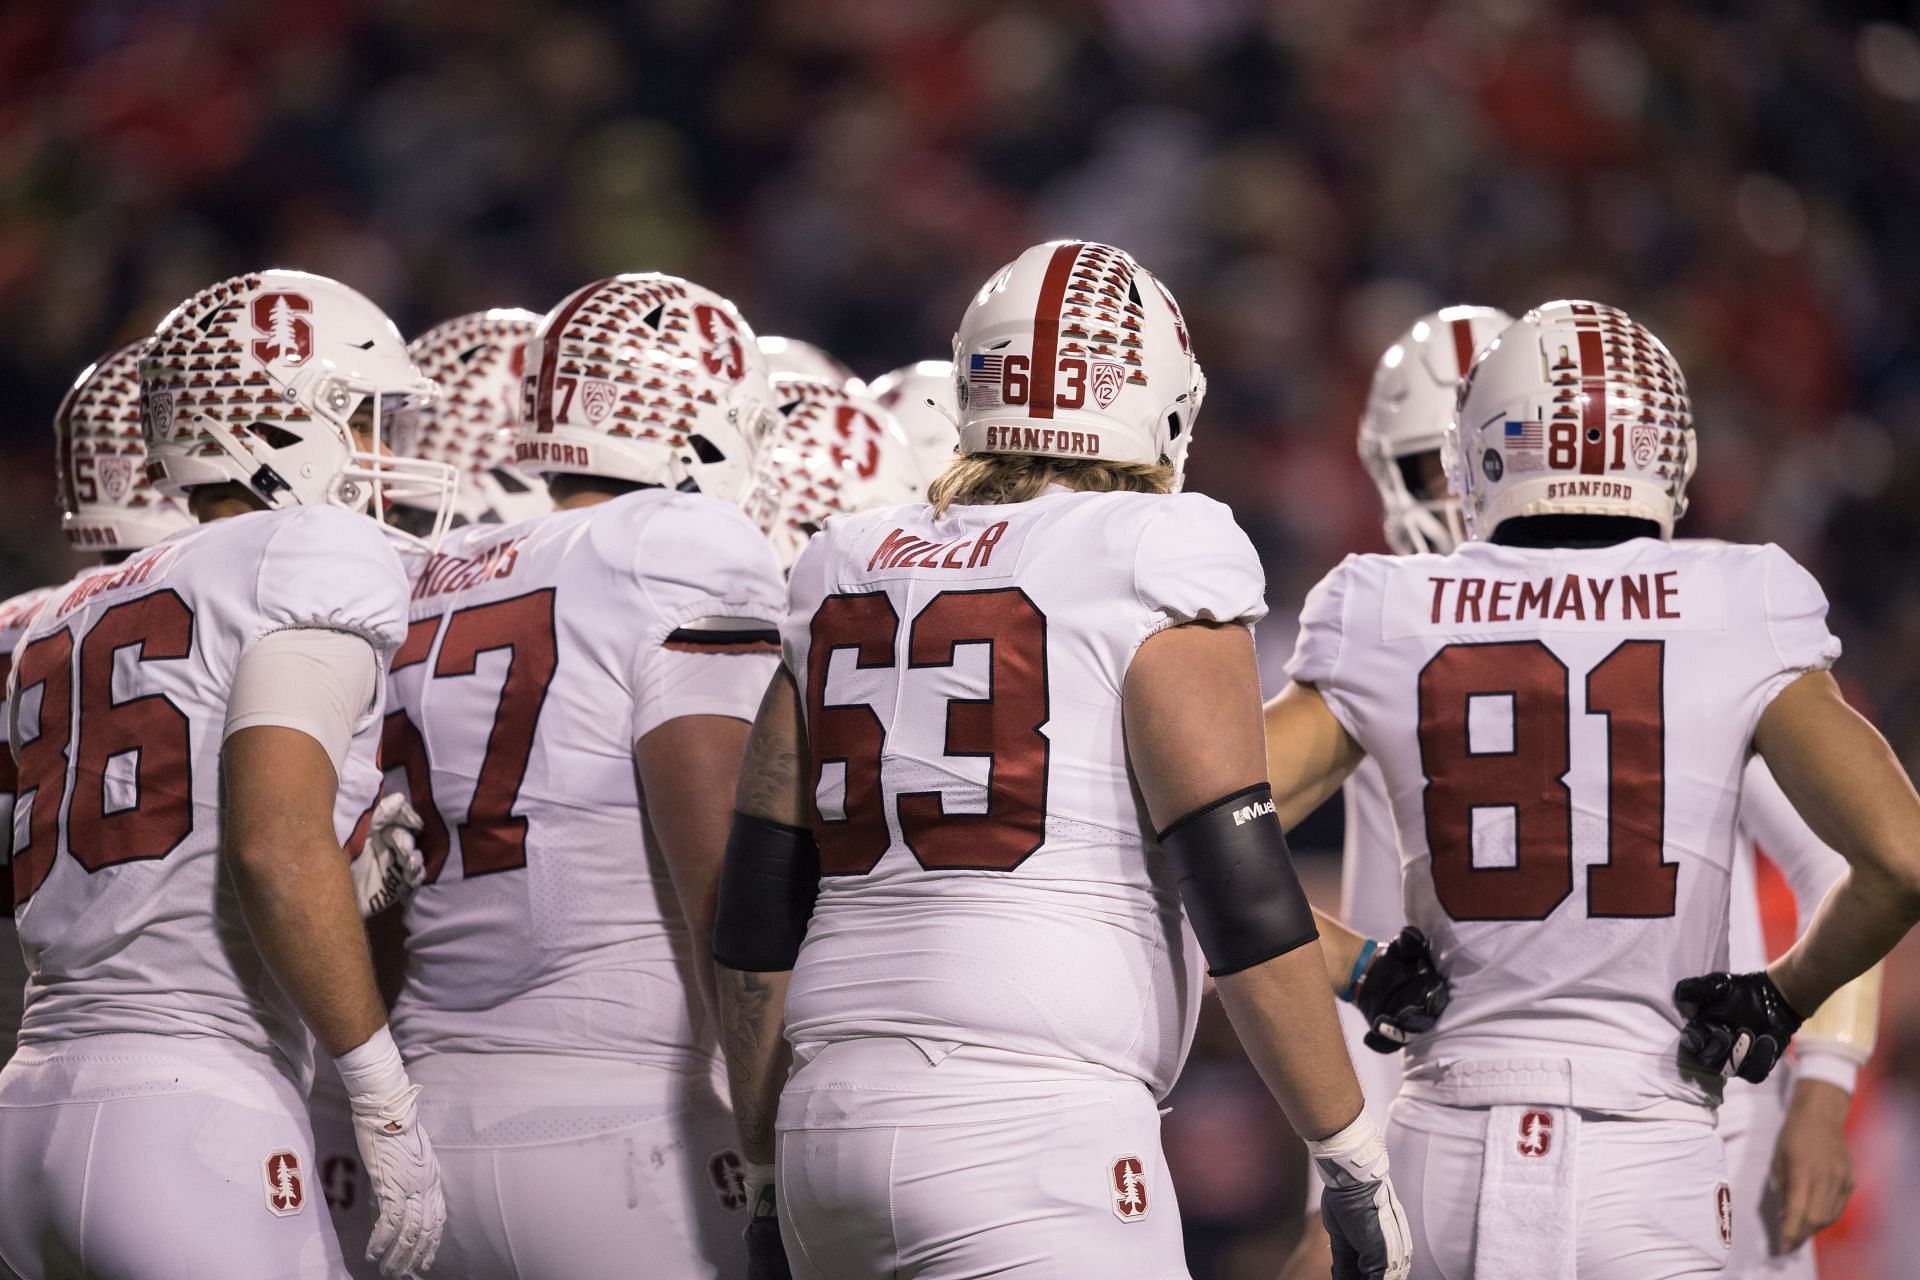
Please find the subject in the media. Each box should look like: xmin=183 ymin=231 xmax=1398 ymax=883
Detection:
xmin=1288 ymin=539 xmax=1839 ymax=1111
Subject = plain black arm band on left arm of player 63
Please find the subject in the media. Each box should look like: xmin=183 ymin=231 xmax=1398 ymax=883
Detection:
xmin=714 ymin=814 xmax=820 ymax=973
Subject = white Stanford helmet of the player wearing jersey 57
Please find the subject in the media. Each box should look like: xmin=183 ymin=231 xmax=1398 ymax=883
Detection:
xmin=513 ymin=273 xmax=772 ymax=503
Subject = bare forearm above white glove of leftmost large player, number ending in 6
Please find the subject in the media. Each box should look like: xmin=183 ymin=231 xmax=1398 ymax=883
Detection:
xmin=227 ymin=831 xmax=386 ymax=1055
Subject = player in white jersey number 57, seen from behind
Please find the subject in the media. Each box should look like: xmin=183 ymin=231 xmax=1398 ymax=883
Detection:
xmin=384 ymin=274 xmax=785 ymax=1280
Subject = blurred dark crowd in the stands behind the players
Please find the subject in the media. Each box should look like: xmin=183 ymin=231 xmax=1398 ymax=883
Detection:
xmin=0 ymin=0 xmax=1920 ymax=1280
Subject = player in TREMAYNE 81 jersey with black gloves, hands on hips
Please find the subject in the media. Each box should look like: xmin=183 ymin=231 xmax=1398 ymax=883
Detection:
xmin=1267 ymin=301 xmax=1920 ymax=1280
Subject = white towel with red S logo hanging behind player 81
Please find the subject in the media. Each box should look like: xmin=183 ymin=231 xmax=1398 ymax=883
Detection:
xmin=1473 ymin=1107 xmax=1580 ymax=1280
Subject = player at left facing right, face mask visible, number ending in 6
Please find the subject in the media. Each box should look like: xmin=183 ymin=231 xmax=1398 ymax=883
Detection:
xmin=0 ymin=271 xmax=453 ymax=1280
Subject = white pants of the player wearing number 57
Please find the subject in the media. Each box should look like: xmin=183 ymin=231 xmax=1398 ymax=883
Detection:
xmin=407 ymin=1054 xmax=747 ymax=1280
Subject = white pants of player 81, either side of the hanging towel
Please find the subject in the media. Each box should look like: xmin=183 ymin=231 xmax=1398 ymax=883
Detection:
xmin=1386 ymin=1096 xmax=1728 ymax=1280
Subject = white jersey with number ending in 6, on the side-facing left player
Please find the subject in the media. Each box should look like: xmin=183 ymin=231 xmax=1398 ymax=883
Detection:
xmin=10 ymin=507 xmax=407 ymax=1073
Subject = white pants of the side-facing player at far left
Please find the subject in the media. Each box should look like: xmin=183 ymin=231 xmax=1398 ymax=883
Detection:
xmin=0 ymin=1034 xmax=348 ymax=1280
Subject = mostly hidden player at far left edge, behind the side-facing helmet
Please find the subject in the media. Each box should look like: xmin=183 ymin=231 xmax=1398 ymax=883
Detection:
xmin=0 ymin=340 xmax=194 ymax=1065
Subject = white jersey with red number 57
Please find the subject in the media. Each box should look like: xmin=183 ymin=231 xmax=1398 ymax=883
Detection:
xmin=382 ymin=489 xmax=785 ymax=1071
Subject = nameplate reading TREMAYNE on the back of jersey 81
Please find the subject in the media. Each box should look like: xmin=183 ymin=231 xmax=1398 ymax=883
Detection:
xmin=1380 ymin=564 xmax=1726 ymax=641
